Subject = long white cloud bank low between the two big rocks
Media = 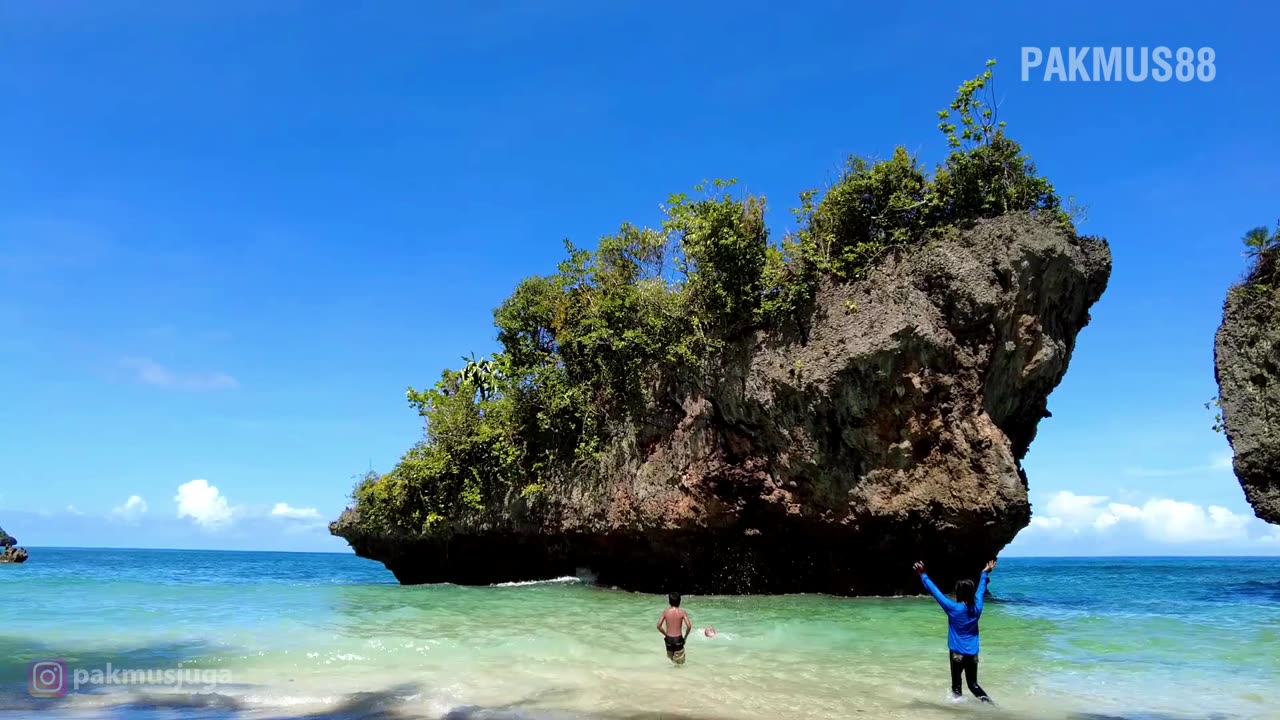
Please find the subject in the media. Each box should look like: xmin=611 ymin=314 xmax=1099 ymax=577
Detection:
xmin=1032 ymin=491 xmax=1253 ymax=543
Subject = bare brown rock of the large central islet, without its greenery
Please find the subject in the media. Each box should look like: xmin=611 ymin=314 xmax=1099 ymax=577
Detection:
xmin=330 ymin=217 xmax=1111 ymax=594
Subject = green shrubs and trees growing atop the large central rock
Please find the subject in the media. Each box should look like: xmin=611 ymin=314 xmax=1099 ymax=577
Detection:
xmin=352 ymin=63 xmax=1070 ymax=532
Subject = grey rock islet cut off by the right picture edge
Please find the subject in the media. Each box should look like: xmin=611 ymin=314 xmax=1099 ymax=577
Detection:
xmin=1213 ymin=223 xmax=1280 ymax=524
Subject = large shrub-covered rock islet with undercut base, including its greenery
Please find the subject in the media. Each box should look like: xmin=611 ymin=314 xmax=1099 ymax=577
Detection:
xmin=330 ymin=68 xmax=1111 ymax=594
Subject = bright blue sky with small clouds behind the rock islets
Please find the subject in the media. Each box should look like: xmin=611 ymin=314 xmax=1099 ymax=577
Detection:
xmin=0 ymin=0 xmax=1280 ymax=555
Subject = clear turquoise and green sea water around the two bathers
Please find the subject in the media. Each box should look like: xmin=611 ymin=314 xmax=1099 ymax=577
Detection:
xmin=0 ymin=548 xmax=1280 ymax=720
